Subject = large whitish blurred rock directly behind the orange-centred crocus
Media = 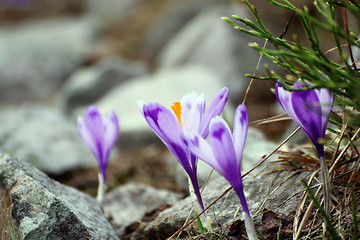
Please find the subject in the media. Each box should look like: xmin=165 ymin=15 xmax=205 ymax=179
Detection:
xmin=93 ymin=65 xmax=228 ymax=145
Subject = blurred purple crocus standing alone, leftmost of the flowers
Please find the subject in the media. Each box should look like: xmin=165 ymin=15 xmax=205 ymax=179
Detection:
xmin=78 ymin=106 xmax=119 ymax=202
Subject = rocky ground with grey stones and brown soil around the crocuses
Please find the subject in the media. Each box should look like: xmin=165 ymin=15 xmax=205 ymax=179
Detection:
xmin=0 ymin=0 xmax=356 ymax=239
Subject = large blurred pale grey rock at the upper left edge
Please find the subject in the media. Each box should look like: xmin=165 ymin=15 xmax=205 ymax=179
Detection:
xmin=0 ymin=19 xmax=93 ymax=102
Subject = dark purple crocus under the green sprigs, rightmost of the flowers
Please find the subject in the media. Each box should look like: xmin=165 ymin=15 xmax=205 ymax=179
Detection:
xmin=275 ymin=81 xmax=334 ymax=158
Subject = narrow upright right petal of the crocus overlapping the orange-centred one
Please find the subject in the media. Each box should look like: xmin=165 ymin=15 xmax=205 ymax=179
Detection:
xmin=233 ymin=104 xmax=248 ymax=166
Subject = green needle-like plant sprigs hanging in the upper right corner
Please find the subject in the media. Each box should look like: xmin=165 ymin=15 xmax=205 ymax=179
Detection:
xmin=223 ymin=0 xmax=360 ymax=117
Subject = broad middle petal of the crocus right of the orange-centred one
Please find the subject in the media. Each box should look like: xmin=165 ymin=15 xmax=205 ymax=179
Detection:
xmin=208 ymin=116 xmax=240 ymax=184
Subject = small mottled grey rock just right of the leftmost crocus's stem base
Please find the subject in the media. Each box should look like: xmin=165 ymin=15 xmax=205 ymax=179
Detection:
xmin=102 ymin=183 xmax=180 ymax=235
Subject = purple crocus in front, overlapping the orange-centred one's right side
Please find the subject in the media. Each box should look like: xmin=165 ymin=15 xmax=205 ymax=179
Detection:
xmin=185 ymin=104 xmax=257 ymax=239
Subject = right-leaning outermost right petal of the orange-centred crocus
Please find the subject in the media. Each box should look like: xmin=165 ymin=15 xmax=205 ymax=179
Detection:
xmin=200 ymin=87 xmax=229 ymax=138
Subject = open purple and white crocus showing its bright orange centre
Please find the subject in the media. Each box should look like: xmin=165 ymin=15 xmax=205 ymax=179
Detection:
xmin=139 ymin=88 xmax=228 ymax=209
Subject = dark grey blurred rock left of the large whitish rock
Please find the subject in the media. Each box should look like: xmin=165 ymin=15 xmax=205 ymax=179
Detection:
xmin=58 ymin=57 xmax=149 ymax=112
